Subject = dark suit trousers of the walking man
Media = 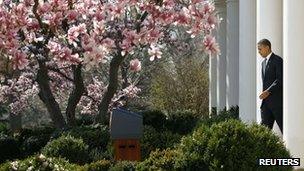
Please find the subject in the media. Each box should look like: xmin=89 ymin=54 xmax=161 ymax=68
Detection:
xmin=261 ymin=104 xmax=283 ymax=134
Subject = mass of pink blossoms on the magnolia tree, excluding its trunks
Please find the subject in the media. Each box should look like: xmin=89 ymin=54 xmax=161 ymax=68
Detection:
xmin=0 ymin=0 xmax=219 ymax=117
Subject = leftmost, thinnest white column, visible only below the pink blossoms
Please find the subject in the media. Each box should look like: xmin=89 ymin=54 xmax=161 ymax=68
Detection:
xmin=209 ymin=56 xmax=217 ymax=114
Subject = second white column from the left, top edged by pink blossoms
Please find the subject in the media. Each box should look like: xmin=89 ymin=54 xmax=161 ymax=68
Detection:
xmin=215 ymin=0 xmax=227 ymax=112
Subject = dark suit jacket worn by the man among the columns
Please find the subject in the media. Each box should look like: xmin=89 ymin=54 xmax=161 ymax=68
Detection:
xmin=261 ymin=53 xmax=283 ymax=109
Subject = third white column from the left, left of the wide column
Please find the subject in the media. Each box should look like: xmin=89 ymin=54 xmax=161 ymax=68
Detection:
xmin=226 ymin=0 xmax=239 ymax=109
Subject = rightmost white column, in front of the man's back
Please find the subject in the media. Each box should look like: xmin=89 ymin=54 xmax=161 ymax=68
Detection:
xmin=283 ymin=0 xmax=304 ymax=168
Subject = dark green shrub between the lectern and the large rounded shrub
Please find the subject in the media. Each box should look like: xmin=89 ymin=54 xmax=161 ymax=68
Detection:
xmin=140 ymin=126 xmax=181 ymax=159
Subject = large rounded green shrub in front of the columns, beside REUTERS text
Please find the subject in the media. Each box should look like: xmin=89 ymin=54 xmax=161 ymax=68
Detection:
xmin=175 ymin=120 xmax=291 ymax=170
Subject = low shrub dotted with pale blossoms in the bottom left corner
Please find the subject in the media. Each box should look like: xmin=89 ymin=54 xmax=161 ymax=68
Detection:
xmin=0 ymin=155 xmax=80 ymax=171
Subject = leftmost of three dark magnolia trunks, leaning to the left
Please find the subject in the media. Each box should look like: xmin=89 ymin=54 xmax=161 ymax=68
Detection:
xmin=37 ymin=61 xmax=66 ymax=128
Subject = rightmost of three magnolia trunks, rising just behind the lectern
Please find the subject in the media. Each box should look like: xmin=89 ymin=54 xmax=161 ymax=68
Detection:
xmin=95 ymin=52 xmax=124 ymax=125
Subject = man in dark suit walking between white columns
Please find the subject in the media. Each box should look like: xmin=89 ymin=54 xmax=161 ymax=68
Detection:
xmin=258 ymin=39 xmax=283 ymax=133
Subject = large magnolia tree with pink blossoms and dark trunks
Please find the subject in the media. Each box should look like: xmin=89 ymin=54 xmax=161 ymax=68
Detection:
xmin=0 ymin=0 xmax=219 ymax=127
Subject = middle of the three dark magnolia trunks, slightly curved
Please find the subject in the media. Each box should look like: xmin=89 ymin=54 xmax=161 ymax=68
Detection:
xmin=66 ymin=65 xmax=85 ymax=126
